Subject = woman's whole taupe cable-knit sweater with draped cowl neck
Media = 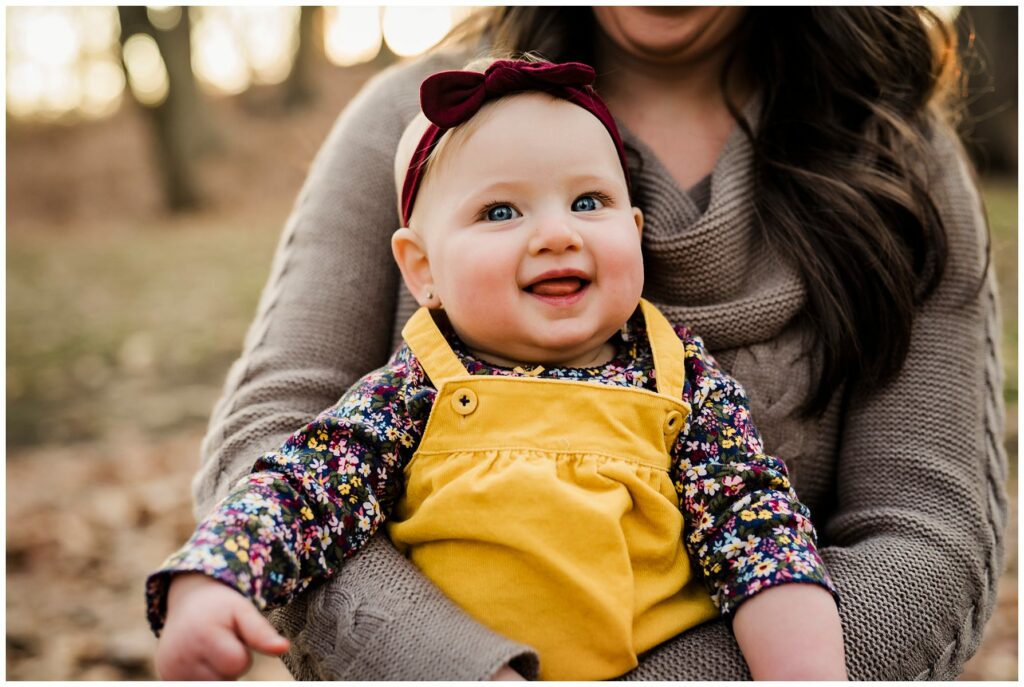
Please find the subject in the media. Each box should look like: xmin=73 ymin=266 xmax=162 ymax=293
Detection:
xmin=194 ymin=54 xmax=1008 ymax=680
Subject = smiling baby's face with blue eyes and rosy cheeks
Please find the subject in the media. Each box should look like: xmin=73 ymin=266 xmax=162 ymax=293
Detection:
xmin=395 ymin=93 xmax=643 ymax=366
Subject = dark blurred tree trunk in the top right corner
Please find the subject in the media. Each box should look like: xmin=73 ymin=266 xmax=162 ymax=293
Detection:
xmin=956 ymin=6 xmax=1018 ymax=174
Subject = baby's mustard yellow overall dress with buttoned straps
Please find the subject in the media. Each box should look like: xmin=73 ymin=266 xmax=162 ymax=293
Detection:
xmin=388 ymin=301 xmax=717 ymax=680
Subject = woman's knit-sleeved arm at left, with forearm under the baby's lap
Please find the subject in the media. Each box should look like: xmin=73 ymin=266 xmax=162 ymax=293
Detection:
xmin=194 ymin=51 xmax=536 ymax=680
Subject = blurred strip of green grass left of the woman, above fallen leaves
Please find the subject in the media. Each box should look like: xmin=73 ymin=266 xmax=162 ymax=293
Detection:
xmin=7 ymin=218 xmax=281 ymax=446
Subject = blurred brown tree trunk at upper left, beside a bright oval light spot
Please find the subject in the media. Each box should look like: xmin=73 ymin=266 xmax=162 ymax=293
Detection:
xmin=118 ymin=5 xmax=217 ymax=212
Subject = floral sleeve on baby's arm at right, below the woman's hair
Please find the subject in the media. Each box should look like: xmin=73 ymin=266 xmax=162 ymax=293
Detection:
xmin=673 ymin=330 xmax=837 ymax=613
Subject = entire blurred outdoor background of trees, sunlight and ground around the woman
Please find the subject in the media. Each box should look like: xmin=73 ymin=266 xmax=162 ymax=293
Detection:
xmin=5 ymin=6 xmax=1018 ymax=680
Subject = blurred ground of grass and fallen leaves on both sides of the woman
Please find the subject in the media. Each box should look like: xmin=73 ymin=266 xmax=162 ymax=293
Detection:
xmin=7 ymin=175 xmax=1017 ymax=680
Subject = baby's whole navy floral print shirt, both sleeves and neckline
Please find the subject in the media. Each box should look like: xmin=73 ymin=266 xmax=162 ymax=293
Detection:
xmin=146 ymin=310 xmax=836 ymax=634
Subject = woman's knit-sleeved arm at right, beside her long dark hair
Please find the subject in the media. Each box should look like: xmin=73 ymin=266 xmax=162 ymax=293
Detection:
xmin=626 ymin=126 xmax=1008 ymax=680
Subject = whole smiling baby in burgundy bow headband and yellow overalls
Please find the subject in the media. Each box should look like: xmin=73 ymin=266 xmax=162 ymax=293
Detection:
xmin=146 ymin=60 xmax=846 ymax=680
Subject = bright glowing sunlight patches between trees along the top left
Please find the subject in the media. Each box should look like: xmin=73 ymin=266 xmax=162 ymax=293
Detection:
xmin=6 ymin=5 xmax=472 ymax=119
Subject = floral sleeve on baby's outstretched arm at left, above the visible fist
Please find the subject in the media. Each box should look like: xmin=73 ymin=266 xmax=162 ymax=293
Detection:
xmin=146 ymin=347 xmax=436 ymax=635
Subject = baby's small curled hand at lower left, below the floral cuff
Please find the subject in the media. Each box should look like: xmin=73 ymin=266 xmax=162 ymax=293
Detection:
xmin=157 ymin=572 xmax=288 ymax=680
